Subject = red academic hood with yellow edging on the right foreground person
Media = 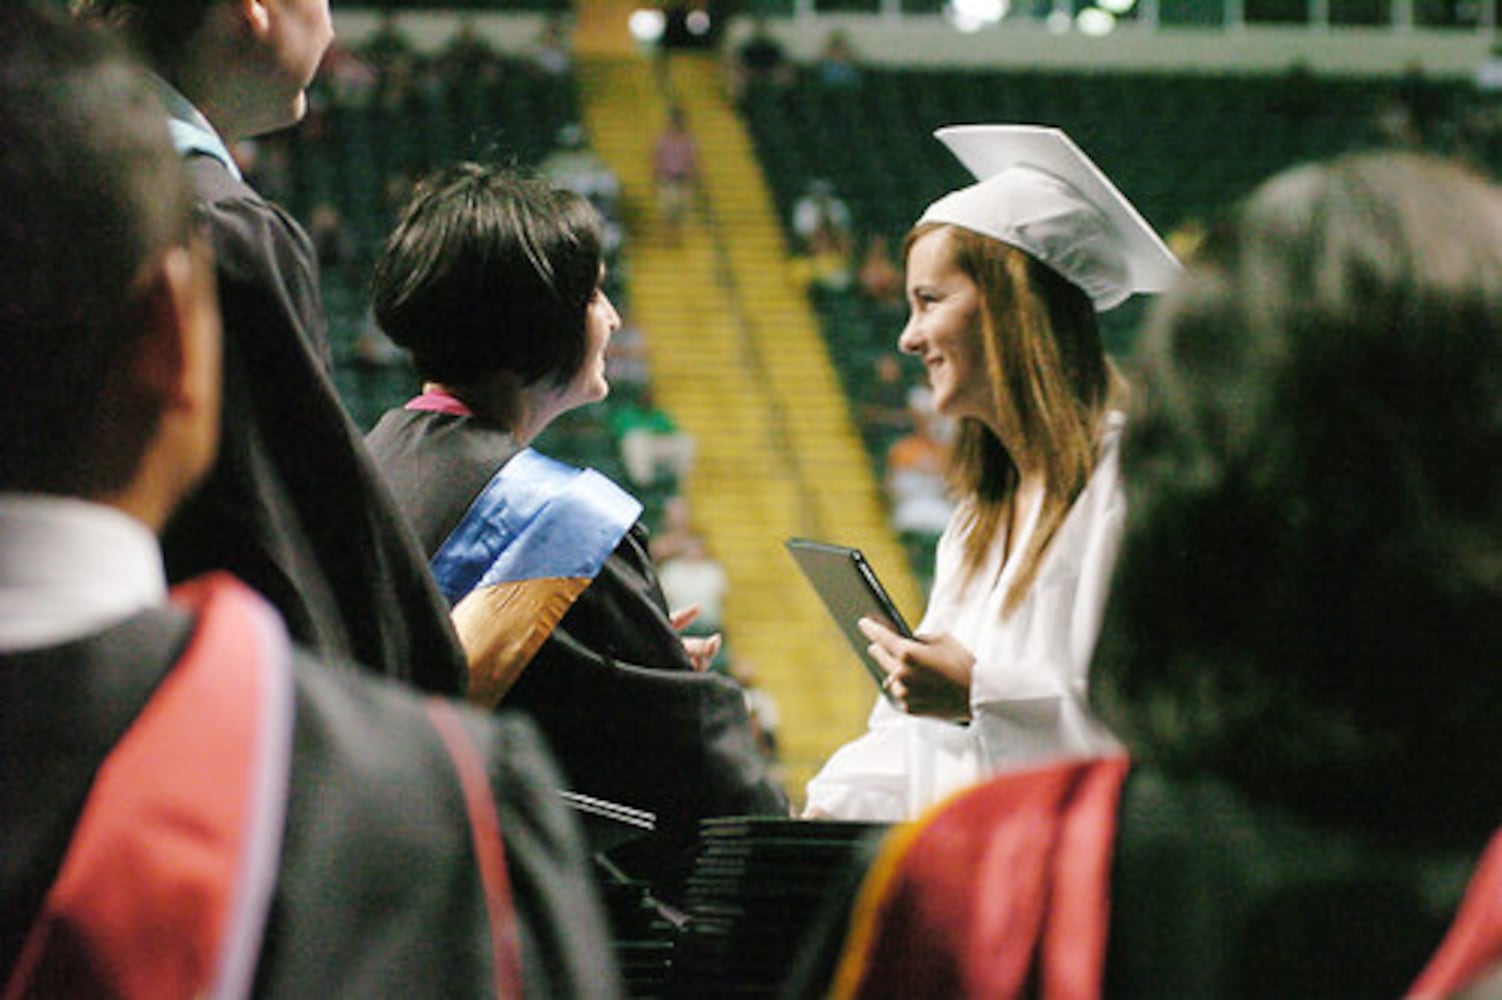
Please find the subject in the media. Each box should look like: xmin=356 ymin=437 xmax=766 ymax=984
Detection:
xmin=832 ymin=757 xmax=1502 ymax=1000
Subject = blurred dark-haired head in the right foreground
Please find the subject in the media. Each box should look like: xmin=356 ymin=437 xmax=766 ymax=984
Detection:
xmin=1093 ymin=153 xmax=1502 ymax=835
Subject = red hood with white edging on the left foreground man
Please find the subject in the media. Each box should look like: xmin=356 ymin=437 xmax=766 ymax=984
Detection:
xmin=5 ymin=575 xmax=293 ymax=1000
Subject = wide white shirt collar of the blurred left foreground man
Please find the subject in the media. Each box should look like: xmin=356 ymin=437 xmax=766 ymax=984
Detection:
xmin=0 ymin=492 xmax=167 ymax=652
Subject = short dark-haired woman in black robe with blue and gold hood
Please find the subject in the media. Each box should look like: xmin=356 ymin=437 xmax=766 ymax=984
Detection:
xmin=369 ymin=164 xmax=786 ymax=854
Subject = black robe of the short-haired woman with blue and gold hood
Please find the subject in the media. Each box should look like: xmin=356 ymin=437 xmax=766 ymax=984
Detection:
xmin=368 ymin=410 xmax=787 ymax=841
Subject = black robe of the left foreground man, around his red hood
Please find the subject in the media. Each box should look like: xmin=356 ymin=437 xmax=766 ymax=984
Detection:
xmin=0 ymin=591 xmax=619 ymax=997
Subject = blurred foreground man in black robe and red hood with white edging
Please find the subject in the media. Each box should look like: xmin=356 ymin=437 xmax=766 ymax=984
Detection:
xmin=0 ymin=13 xmax=617 ymax=997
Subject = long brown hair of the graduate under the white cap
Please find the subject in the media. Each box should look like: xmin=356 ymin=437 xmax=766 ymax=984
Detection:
xmin=906 ymin=224 xmax=1123 ymax=616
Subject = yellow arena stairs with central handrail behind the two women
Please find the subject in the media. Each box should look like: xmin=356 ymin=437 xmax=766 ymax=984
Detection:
xmin=580 ymin=54 xmax=921 ymax=796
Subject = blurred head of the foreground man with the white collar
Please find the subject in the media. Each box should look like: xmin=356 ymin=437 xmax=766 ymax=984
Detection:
xmin=0 ymin=8 xmax=219 ymax=529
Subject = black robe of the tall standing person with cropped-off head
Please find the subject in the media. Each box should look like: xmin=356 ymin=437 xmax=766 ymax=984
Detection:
xmin=162 ymin=156 xmax=464 ymax=694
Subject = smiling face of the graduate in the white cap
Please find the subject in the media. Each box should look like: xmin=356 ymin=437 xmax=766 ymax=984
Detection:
xmin=897 ymin=227 xmax=997 ymax=426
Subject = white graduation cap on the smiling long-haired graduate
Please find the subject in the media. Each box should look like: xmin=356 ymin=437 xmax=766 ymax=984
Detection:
xmin=918 ymin=125 xmax=1179 ymax=312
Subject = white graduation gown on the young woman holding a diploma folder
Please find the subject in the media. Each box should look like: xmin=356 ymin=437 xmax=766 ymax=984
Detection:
xmin=807 ymin=413 xmax=1127 ymax=821
